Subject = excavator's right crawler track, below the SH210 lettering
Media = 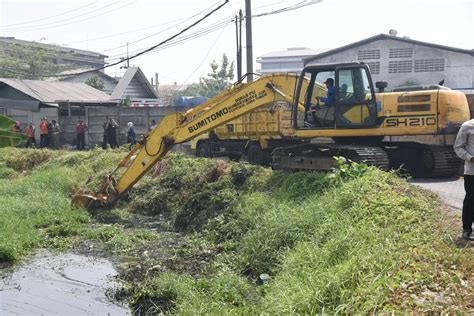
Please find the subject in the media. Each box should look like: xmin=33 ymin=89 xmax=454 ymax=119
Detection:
xmin=385 ymin=142 xmax=462 ymax=178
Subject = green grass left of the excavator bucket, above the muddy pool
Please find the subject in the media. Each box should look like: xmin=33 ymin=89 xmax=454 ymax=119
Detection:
xmin=0 ymin=148 xmax=154 ymax=266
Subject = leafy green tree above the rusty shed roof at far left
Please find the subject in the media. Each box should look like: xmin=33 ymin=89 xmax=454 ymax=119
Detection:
xmin=0 ymin=44 xmax=71 ymax=80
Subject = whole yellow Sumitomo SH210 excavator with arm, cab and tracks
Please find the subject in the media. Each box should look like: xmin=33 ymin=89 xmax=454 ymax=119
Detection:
xmin=73 ymin=63 xmax=469 ymax=208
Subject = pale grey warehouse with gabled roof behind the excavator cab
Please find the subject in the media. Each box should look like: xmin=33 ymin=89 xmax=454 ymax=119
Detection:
xmin=257 ymin=32 xmax=474 ymax=90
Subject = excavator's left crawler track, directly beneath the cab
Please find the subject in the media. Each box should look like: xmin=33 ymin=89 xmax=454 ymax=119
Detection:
xmin=272 ymin=144 xmax=389 ymax=171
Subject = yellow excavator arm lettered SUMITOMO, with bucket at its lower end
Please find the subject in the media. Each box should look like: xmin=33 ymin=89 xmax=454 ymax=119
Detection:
xmin=73 ymin=74 xmax=308 ymax=209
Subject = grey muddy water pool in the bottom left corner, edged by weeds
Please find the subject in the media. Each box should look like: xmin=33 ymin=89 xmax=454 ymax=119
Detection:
xmin=0 ymin=253 xmax=130 ymax=316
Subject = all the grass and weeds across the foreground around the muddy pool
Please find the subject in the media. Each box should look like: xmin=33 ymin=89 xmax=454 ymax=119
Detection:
xmin=0 ymin=149 xmax=474 ymax=314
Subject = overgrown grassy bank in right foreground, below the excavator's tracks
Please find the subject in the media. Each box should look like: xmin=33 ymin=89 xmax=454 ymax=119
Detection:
xmin=123 ymin=156 xmax=474 ymax=314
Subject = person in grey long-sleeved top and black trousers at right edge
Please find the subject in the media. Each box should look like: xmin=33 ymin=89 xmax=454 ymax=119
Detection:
xmin=454 ymin=119 xmax=474 ymax=240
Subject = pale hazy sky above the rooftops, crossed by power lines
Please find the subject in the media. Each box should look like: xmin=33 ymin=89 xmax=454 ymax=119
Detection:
xmin=0 ymin=0 xmax=474 ymax=85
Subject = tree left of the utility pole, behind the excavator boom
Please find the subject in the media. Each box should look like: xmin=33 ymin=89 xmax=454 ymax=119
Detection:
xmin=174 ymin=54 xmax=234 ymax=100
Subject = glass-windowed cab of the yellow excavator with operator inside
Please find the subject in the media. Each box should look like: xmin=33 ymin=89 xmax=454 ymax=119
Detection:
xmin=293 ymin=63 xmax=377 ymax=129
